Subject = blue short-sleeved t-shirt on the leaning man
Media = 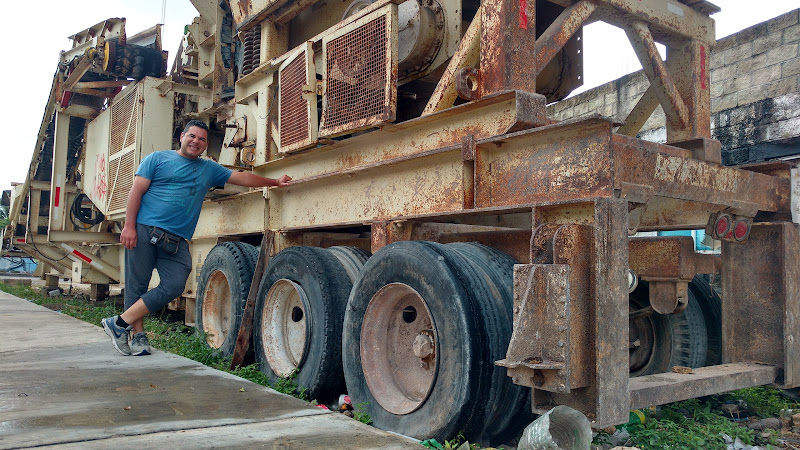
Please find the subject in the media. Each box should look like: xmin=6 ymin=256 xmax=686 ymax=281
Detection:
xmin=136 ymin=150 xmax=232 ymax=240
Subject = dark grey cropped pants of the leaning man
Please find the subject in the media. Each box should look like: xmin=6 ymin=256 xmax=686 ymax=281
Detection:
xmin=125 ymin=224 xmax=192 ymax=313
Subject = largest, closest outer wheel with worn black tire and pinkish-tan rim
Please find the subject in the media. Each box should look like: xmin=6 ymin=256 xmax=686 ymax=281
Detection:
xmin=342 ymin=241 xmax=493 ymax=440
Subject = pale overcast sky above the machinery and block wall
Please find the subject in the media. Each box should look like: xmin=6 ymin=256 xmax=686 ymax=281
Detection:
xmin=0 ymin=0 xmax=800 ymax=190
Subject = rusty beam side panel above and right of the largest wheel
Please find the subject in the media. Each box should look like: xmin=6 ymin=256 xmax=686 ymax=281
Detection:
xmin=475 ymin=120 xmax=613 ymax=207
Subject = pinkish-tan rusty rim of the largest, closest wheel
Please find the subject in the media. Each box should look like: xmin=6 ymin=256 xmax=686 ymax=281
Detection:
xmin=360 ymin=283 xmax=439 ymax=415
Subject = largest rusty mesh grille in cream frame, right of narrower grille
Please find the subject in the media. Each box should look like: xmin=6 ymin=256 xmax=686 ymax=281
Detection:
xmin=319 ymin=15 xmax=394 ymax=136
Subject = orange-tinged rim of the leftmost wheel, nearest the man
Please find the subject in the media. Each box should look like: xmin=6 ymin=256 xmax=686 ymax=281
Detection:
xmin=203 ymin=270 xmax=231 ymax=348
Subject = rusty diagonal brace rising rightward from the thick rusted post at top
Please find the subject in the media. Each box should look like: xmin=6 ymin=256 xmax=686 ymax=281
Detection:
xmin=533 ymin=0 xmax=597 ymax=80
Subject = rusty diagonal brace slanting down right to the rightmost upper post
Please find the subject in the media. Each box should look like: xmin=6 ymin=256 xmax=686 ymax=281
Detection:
xmin=625 ymin=21 xmax=689 ymax=129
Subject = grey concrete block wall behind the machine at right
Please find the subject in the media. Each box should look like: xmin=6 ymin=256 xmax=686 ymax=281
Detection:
xmin=547 ymin=9 xmax=800 ymax=165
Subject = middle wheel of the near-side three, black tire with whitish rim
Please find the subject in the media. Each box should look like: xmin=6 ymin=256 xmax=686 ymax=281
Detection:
xmin=253 ymin=247 xmax=352 ymax=403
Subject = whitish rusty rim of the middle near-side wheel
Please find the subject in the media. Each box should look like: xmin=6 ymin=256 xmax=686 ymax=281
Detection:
xmin=261 ymin=279 xmax=310 ymax=378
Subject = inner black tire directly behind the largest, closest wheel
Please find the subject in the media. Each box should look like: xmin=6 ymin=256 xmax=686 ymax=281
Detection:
xmin=445 ymin=243 xmax=534 ymax=445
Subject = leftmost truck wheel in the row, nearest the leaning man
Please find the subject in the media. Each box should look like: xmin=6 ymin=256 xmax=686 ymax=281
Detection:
xmin=195 ymin=242 xmax=255 ymax=356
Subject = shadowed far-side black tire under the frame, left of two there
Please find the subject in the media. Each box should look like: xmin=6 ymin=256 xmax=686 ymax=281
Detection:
xmin=629 ymin=281 xmax=708 ymax=377
